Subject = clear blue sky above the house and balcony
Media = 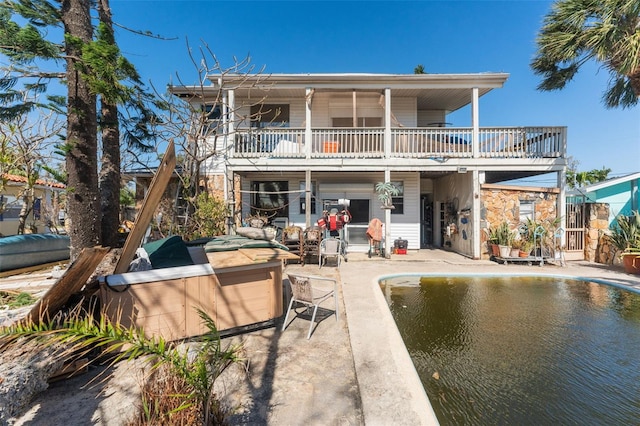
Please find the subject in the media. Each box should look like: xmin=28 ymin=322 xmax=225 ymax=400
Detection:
xmin=111 ymin=0 xmax=640 ymax=180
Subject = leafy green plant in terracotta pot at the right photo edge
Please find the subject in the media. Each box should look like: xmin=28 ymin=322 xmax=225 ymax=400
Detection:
xmin=609 ymin=210 xmax=640 ymax=274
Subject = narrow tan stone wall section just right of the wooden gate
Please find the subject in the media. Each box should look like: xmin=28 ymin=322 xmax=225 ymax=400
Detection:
xmin=584 ymin=203 xmax=616 ymax=264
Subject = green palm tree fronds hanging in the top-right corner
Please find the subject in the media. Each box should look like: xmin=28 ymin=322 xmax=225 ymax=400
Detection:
xmin=531 ymin=0 xmax=640 ymax=108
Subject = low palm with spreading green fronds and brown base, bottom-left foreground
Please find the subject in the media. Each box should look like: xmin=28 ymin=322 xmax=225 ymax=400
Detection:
xmin=0 ymin=306 xmax=243 ymax=426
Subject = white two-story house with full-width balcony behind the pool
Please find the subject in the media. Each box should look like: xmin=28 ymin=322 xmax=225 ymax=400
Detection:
xmin=171 ymin=73 xmax=566 ymax=258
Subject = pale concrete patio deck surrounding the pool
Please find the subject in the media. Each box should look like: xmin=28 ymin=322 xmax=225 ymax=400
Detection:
xmin=5 ymin=250 xmax=640 ymax=426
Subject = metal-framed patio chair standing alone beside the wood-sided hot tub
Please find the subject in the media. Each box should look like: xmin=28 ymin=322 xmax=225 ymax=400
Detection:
xmin=282 ymin=274 xmax=338 ymax=339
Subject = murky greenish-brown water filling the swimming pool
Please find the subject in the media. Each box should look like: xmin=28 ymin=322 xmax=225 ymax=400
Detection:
xmin=380 ymin=276 xmax=640 ymax=425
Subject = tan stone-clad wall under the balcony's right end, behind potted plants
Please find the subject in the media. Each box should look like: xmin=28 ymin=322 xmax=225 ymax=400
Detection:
xmin=480 ymin=184 xmax=559 ymax=259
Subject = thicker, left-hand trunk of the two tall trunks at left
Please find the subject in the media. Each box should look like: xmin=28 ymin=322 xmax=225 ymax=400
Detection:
xmin=61 ymin=0 xmax=100 ymax=260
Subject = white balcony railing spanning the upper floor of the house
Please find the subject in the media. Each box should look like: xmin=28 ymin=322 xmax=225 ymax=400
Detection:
xmin=229 ymin=127 xmax=566 ymax=159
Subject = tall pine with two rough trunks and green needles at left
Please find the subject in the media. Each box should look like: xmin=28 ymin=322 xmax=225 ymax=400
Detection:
xmin=0 ymin=0 xmax=155 ymax=259
